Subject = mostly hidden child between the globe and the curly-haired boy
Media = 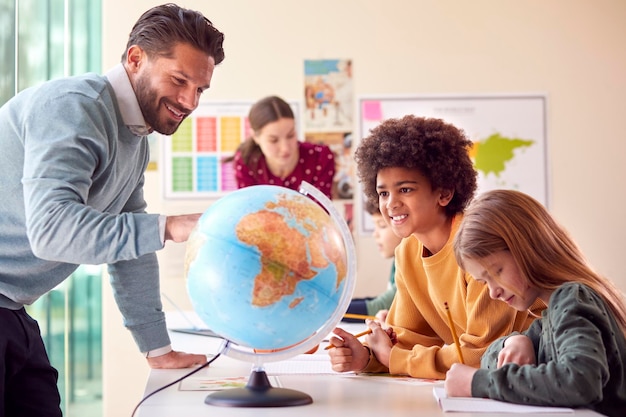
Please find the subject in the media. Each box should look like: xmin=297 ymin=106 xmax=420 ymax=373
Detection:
xmin=343 ymin=201 xmax=402 ymax=323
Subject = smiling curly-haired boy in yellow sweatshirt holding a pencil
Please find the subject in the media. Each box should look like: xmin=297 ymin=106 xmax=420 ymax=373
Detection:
xmin=328 ymin=116 xmax=545 ymax=379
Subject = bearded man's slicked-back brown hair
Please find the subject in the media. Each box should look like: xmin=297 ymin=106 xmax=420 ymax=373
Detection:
xmin=122 ymin=3 xmax=224 ymax=65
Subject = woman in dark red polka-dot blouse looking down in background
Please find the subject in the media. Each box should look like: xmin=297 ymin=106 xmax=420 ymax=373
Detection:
xmin=225 ymin=96 xmax=335 ymax=198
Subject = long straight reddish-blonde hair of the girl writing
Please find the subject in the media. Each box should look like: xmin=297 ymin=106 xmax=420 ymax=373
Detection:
xmin=454 ymin=190 xmax=626 ymax=334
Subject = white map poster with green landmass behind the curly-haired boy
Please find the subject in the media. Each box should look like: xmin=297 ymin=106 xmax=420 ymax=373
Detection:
xmin=358 ymin=94 xmax=548 ymax=234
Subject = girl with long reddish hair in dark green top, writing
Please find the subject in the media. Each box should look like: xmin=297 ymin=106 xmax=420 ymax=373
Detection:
xmin=445 ymin=190 xmax=626 ymax=417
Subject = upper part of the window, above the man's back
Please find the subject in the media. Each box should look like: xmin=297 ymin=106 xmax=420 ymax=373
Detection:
xmin=0 ymin=0 xmax=102 ymax=104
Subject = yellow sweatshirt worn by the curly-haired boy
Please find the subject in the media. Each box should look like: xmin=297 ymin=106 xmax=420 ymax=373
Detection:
xmin=361 ymin=215 xmax=545 ymax=379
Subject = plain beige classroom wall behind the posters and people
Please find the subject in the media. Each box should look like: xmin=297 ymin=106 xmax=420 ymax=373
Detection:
xmin=103 ymin=0 xmax=626 ymax=416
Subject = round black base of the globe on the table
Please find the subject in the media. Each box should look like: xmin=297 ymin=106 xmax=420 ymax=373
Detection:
xmin=204 ymin=370 xmax=313 ymax=407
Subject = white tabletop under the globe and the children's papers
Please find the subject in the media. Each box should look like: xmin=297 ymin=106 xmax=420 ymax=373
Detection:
xmin=137 ymin=316 xmax=600 ymax=417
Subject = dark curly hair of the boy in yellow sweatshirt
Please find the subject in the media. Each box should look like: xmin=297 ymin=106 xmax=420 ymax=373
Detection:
xmin=355 ymin=115 xmax=476 ymax=216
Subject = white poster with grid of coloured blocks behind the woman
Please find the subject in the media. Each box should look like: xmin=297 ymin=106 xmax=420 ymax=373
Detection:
xmin=160 ymin=101 xmax=300 ymax=199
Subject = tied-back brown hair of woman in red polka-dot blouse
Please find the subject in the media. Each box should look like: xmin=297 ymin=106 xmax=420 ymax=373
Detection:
xmin=222 ymin=96 xmax=295 ymax=165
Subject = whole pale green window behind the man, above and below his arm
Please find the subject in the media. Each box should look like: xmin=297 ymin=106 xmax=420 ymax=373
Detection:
xmin=0 ymin=0 xmax=102 ymax=417
